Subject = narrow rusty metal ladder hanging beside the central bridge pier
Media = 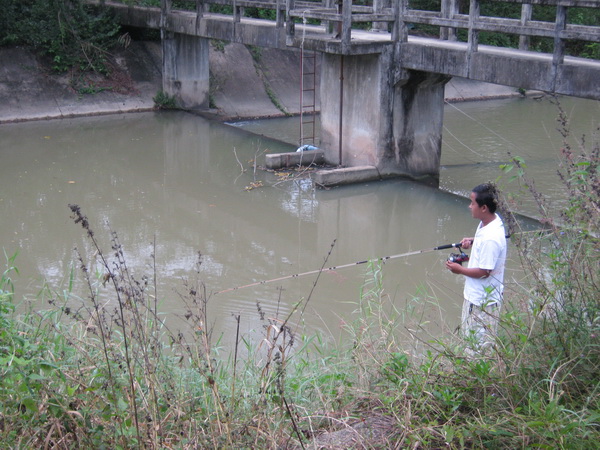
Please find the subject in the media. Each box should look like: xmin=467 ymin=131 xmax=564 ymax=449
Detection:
xmin=300 ymin=48 xmax=317 ymax=146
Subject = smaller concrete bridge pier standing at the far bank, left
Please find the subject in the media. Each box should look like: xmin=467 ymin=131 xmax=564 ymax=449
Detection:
xmin=162 ymin=32 xmax=210 ymax=109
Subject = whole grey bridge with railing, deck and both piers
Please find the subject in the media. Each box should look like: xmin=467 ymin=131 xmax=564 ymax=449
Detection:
xmin=92 ymin=0 xmax=600 ymax=185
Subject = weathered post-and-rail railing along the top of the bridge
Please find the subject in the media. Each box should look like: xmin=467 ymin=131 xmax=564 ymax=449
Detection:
xmin=101 ymin=0 xmax=600 ymax=65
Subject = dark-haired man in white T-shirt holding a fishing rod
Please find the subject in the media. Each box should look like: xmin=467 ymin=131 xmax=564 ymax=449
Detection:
xmin=446 ymin=183 xmax=506 ymax=350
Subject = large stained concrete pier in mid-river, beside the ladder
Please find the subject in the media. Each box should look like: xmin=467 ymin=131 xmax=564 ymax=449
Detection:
xmin=321 ymin=46 xmax=450 ymax=185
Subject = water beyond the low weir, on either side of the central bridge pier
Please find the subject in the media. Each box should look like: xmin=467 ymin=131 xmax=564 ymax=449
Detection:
xmin=238 ymin=96 xmax=600 ymax=215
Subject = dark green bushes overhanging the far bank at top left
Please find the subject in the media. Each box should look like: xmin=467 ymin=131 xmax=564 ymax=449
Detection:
xmin=0 ymin=0 xmax=143 ymax=95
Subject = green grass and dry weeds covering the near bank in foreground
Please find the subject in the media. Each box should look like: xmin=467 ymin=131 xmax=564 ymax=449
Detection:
xmin=0 ymin=103 xmax=600 ymax=449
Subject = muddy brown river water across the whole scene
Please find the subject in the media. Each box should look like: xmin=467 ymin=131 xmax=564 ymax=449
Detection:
xmin=0 ymin=95 xmax=600 ymax=345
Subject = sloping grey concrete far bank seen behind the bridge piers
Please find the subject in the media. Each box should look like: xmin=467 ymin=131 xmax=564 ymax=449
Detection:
xmin=0 ymin=41 xmax=519 ymax=123
